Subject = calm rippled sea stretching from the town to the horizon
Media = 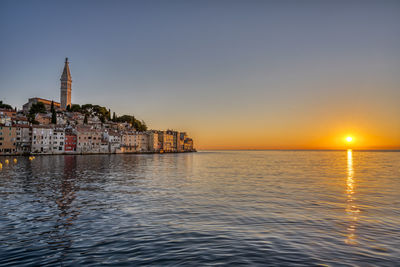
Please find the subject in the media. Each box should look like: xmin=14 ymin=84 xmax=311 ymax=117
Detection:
xmin=0 ymin=151 xmax=400 ymax=266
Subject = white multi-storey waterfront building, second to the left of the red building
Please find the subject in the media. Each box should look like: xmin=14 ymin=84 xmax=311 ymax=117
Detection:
xmin=32 ymin=125 xmax=54 ymax=154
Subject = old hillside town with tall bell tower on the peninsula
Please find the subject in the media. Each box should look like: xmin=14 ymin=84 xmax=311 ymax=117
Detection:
xmin=0 ymin=58 xmax=196 ymax=155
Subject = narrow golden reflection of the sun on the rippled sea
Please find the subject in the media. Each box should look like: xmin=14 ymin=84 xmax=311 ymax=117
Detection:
xmin=346 ymin=149 xmax=360 ymax=244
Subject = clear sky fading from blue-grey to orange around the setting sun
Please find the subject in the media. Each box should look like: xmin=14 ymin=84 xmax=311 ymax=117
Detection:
xmin=0 ymin=0 xmax=400 ymax=149
